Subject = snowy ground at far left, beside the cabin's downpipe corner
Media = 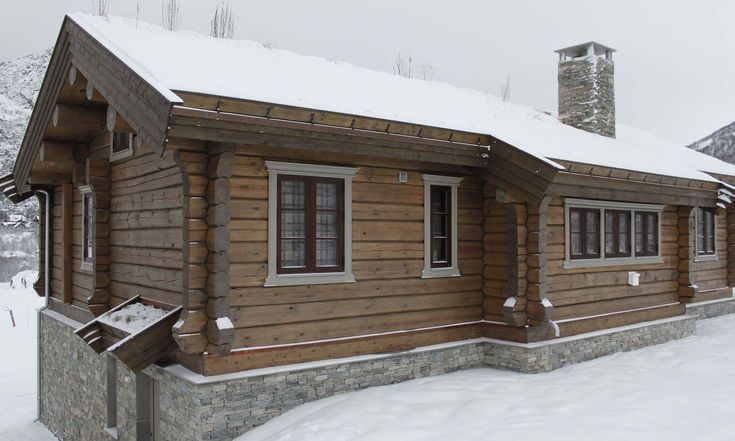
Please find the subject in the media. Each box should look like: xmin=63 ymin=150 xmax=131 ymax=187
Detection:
xmin=0 ymin=271 xmax=56 ymax=441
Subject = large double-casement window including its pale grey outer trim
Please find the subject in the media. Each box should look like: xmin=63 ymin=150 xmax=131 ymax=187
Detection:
xmin=265 ymin=161 xmax=357 ymax=286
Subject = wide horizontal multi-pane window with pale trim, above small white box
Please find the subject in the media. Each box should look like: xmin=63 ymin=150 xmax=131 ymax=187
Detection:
xmin=564 ymin=198 xmax=663 ymax=268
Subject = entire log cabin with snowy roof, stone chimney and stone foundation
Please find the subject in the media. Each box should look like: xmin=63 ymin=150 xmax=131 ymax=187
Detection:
xmin=0 ymin=14 xmax=735 ymax=440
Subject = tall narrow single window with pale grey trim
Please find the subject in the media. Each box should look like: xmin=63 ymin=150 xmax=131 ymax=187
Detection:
xmin=421 ymin=175 xmax=462 ymax=278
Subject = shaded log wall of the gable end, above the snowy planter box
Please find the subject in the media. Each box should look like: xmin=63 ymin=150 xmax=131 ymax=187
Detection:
xmin=51 ymin=132 xmax=184 ymax=321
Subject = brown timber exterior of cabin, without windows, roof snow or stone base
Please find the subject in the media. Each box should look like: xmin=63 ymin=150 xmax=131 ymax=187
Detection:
xmin=3 ymin=20 xmax=735 ymax=375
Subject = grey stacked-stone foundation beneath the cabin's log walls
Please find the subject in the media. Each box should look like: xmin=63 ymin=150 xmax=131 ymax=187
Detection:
xmin=41 ymin=312 xmax=696 ymax=441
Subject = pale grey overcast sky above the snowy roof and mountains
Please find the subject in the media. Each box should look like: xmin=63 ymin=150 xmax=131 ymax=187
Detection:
xmin=0 ymin=0 xmax=735 ymax=144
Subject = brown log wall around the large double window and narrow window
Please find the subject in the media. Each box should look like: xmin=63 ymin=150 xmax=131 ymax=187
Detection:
xmin=229 ymin=151 xmax=483 ymax=348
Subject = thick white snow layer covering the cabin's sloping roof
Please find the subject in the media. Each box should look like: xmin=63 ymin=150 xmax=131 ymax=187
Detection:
xmin=70 ymin=14 xmax=735 ymax=181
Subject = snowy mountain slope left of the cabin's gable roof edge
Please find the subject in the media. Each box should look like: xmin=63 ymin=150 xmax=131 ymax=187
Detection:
xmin=0 ymin=49 xmax=51 ymax=211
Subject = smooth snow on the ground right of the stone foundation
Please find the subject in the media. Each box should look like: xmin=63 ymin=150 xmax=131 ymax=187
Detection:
xmin=242 ymin=315 xmax=735 ymax=441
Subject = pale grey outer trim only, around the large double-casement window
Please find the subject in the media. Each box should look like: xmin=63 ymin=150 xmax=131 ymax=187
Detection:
xmin=264 ymin=161 xmax=358 ymax=287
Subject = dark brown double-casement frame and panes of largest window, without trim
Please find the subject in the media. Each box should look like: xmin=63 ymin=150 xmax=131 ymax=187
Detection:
xmin=278 ymin=175 xmax=344 ymax=274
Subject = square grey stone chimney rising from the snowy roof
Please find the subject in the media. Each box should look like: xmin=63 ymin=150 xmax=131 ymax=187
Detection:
xmin=555 ymin=41 xmax=615 ymax=138
